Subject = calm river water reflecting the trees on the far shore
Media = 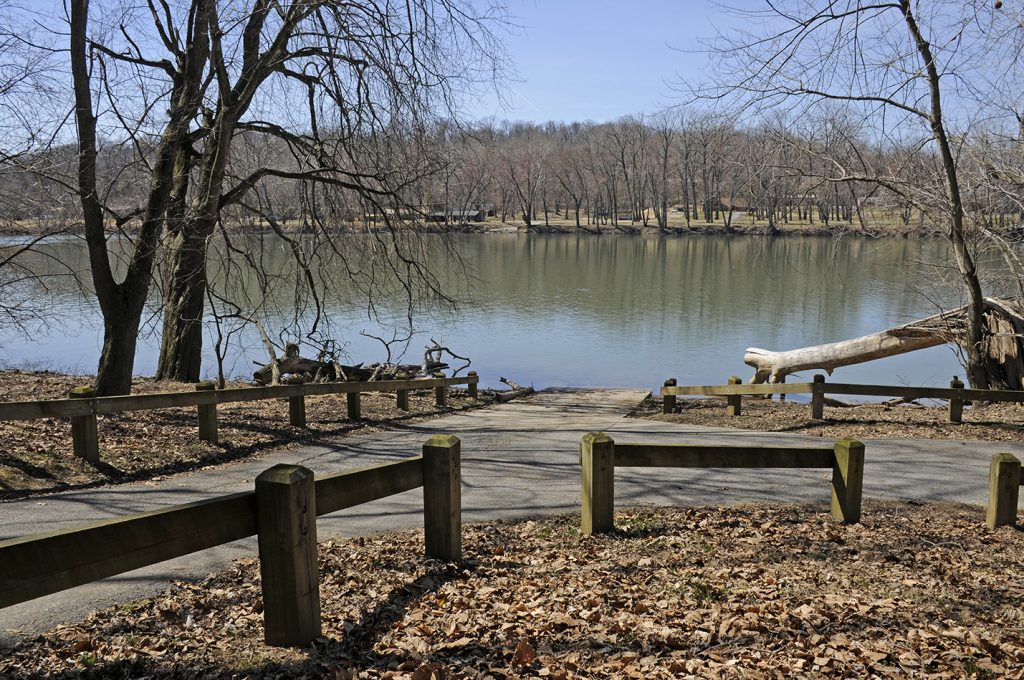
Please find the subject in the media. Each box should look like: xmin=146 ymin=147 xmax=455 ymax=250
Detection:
xmin=0 ymin=233 xmax=1008 ymax=388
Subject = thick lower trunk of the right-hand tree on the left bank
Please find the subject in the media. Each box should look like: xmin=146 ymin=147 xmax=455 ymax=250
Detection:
xmin=157 ymin=236 xmax=207 ymax=382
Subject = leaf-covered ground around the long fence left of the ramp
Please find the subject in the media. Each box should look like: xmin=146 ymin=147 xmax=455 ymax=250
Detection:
xmin=0 ymin=371 xmax=494 ymax=500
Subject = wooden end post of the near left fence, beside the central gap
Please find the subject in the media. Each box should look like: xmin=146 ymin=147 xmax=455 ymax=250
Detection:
xmin=423 ymin=434 xmax=462 ymax=562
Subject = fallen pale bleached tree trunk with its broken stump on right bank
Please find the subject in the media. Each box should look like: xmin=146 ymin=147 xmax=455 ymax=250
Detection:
xmin=743 ymin=298 xmax=1024 ymax=389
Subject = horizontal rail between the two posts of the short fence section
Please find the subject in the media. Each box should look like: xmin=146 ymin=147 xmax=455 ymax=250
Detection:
xmin=615 ymin=443 xmax=836 ymax=469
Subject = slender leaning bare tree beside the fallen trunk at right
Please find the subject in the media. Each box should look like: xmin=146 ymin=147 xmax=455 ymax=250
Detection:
xmin=702 ymin=0 xmax=1019 ymax=388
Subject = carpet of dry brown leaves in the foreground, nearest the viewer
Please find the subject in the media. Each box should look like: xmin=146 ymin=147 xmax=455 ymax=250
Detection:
xmin=0 ymin=502 xmax=1024 ymax=680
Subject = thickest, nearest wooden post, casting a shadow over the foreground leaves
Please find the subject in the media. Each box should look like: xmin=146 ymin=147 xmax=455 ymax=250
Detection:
xmin=256 ymin=465 xmax=321 ymax=646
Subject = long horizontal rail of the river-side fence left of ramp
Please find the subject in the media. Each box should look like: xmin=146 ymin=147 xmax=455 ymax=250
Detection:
xmin=0 ymin=376 xmax=478 ymax=421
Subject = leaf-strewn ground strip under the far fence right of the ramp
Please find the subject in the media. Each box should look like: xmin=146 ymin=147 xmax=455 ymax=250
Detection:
xmin=632 ymin=396 xmax=1024 ymax=441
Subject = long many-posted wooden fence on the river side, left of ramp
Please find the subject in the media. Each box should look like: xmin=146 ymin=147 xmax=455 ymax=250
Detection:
xmin=0 ymin=371 xmax=479 ymax=462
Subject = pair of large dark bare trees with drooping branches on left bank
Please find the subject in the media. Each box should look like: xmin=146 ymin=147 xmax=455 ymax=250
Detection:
xmin=28 ymin=0 xmax=512 ymax=394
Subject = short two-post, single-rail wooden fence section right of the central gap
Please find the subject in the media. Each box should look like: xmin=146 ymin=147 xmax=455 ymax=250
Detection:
xmin=580 ymin=432 xmax=864 ymax=536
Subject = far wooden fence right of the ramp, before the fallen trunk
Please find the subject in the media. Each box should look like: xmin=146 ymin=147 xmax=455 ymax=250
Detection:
xmin=662 ymin=374 xmax=1024 ymax=423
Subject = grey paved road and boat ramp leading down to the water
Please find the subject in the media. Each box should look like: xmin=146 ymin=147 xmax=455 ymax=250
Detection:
xmin=0 ymin=389 xmax=1024 ymax=644
